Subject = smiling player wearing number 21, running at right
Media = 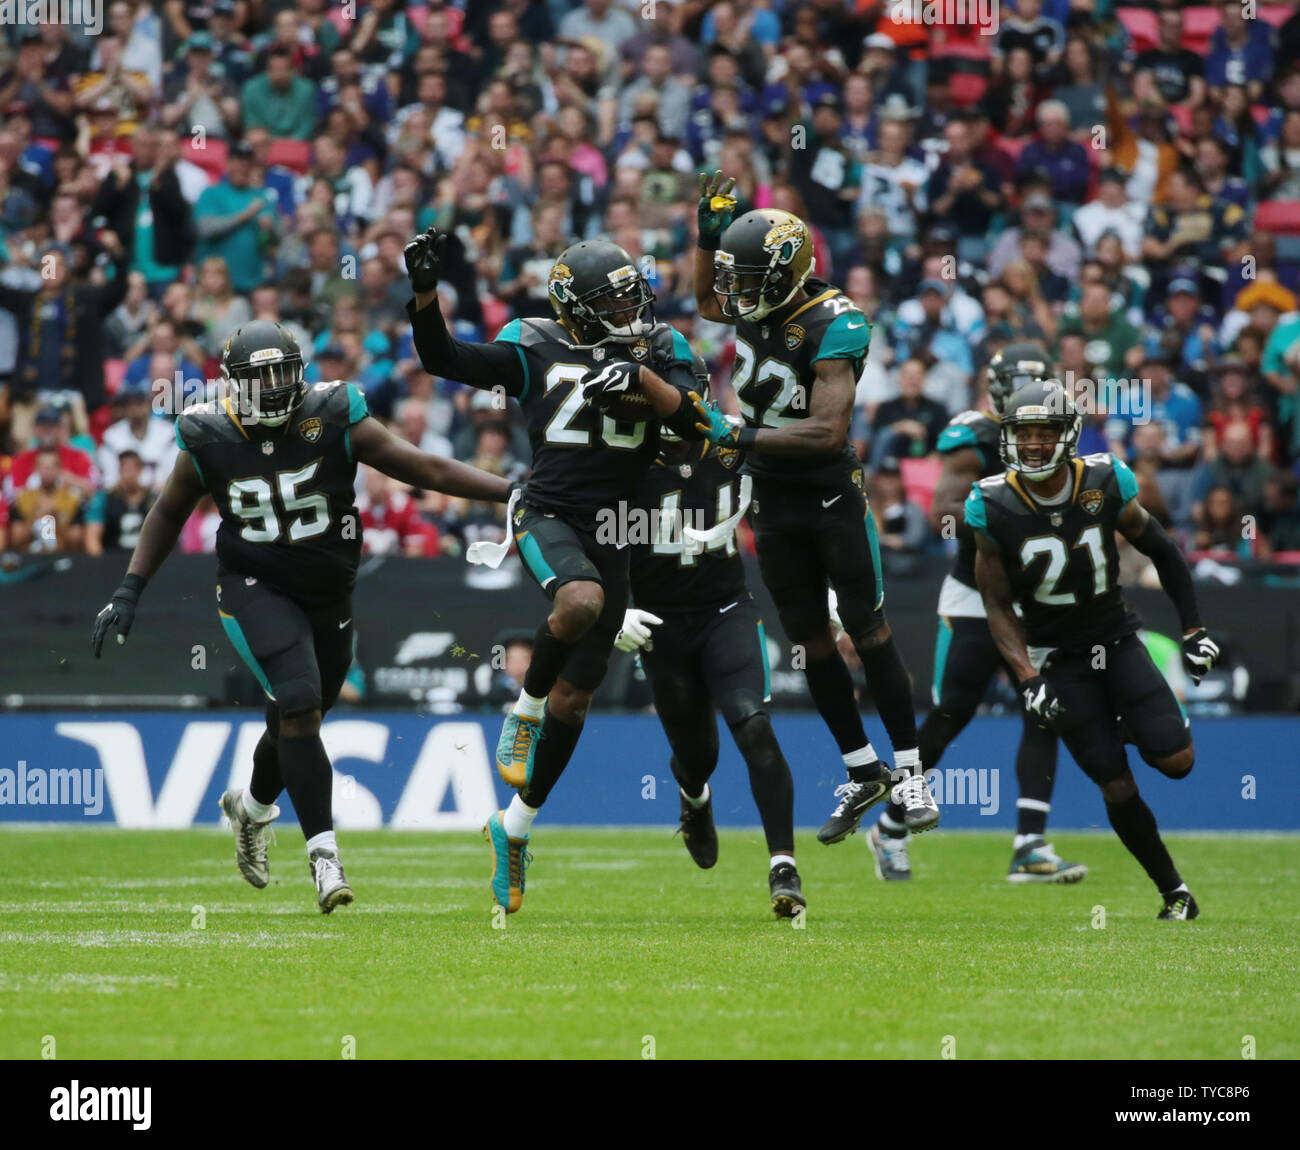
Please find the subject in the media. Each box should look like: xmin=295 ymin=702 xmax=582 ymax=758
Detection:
xmin=966 ymin=379 xmax=1218 ymax=919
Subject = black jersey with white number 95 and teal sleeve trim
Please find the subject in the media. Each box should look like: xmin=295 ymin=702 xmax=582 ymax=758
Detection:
xmin=176 ymin=383 xmax=369 ymax=604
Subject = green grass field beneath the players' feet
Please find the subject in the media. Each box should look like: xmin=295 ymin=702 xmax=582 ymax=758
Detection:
xmin=0 ymin=826 xmax=1300 ymax=1059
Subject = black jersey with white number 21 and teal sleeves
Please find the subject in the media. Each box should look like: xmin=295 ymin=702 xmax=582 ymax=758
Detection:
xmin=966 ymin=454 xmax=1141 ymax=650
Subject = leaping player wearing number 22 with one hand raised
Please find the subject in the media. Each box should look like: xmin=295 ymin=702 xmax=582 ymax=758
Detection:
xmin=696 ymin=173 xmax=939 ymax=843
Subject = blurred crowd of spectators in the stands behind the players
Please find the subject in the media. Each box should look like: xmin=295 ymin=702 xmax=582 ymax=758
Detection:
xmin=0 ymin=0 xmax=1300 ymax=569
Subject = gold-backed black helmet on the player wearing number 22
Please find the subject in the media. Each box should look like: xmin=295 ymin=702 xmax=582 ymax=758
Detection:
xmin=714 ymin=208 xmax=816 ymax=322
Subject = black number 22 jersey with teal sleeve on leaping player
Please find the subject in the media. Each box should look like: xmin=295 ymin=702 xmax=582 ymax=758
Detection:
xmin=732 ymin=279 xmax=871 ymax=487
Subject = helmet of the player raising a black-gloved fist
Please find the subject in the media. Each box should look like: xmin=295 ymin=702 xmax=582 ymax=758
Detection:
xmin=547 ymin=239 xmax=654 ymax=347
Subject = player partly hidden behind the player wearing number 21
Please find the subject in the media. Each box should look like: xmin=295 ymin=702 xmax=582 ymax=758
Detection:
xmin=868 ymin=343 xmax=1088 ymax=882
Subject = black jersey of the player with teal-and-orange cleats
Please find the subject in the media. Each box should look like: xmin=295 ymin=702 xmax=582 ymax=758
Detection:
xmin=497 ymin=320 xmax=694 ymax=530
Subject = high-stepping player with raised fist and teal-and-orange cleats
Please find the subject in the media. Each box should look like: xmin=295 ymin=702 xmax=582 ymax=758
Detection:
xmin=406 ymin=229 xmax=712 ymax=912
